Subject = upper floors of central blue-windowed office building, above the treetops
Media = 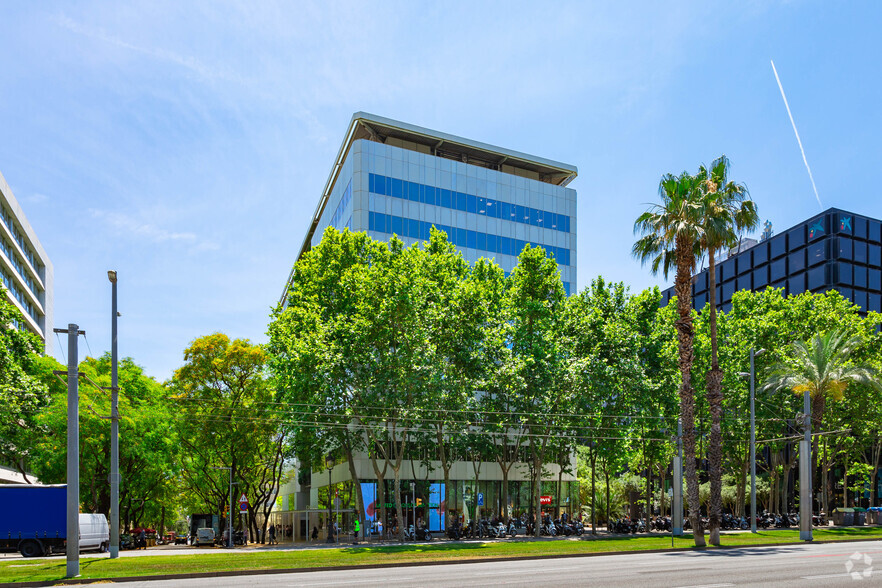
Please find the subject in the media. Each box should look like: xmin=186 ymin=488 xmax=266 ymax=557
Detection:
xmin=282 ymin=112 xmax=578 ymax=301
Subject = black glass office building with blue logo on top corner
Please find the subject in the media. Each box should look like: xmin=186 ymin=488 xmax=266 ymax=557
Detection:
xmin=662 ymin=208 xmax=882 ymax=312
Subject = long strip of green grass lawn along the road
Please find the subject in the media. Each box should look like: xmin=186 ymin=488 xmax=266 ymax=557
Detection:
xmin=0 ymin=527 xmax=882 ymax=584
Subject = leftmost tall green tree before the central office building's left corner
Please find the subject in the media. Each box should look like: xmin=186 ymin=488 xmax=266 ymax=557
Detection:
xmin=267 ymin=227 xmax=386 ymax=528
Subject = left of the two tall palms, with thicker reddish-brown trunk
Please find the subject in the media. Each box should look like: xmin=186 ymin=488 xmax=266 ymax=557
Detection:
xmin=632 ymin=172 xmax=705 ymax=547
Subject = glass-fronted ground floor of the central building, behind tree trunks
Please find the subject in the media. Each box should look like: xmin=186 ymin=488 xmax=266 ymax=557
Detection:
xmin=270 ymin=459 xmax=581 ymax=542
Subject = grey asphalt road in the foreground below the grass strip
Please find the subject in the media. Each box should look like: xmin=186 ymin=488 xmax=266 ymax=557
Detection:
xmin=113 ymin=541 xmax=882 ymax=588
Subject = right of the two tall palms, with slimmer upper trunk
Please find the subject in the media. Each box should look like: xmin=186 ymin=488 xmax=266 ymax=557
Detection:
xmin=696 ymin=155 xmax=759 ymax=545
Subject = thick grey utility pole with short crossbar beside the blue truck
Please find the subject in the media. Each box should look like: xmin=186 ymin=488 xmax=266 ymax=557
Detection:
xmin=53 ymin=323 xmax=86 ymax=578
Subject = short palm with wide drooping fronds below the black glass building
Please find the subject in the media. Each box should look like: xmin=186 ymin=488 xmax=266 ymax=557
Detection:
xmin=762 ymin=327 xmax=882 ymax=512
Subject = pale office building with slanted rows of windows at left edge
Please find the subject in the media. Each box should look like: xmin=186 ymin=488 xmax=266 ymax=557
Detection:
xmin=0 ymin=174 xmax=53 ymax=350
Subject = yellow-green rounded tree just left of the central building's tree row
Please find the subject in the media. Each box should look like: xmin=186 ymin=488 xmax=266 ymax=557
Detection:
xmin=169 ymin=333 xmax=288 ymax=537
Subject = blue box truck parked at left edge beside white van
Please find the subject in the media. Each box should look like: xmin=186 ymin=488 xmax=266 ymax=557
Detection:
xmin=0 ymin=484 xmax=67 ymax=557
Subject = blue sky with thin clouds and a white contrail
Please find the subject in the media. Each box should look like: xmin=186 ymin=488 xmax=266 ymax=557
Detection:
xmin=0 ymin=0 xmax=882 ymax=380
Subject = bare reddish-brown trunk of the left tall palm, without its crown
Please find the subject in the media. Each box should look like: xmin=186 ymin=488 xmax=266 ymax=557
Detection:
xmin=674 ymin=237 xmax=705 ymax=547
